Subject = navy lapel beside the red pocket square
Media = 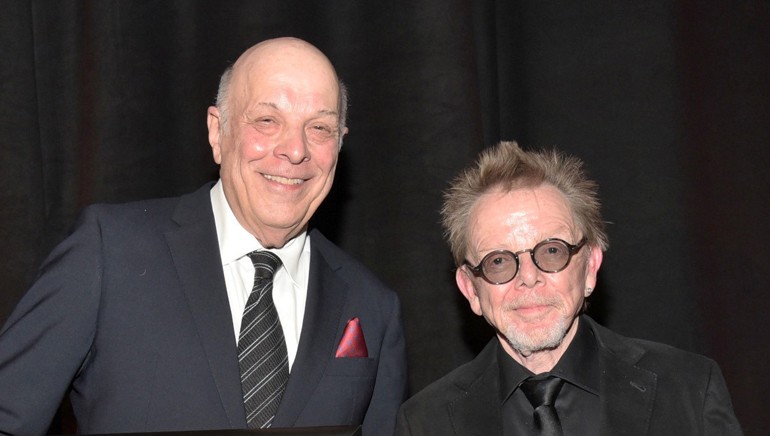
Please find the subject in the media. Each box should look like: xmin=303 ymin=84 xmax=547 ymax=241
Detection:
xmin=273 ymin=233 xmax=348 ymax=427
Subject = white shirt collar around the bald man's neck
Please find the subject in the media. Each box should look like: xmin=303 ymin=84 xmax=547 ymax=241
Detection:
xmin=211 ymin=179 xmax=307 ymax=279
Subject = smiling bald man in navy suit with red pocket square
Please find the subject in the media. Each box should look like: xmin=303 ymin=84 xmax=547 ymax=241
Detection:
xmin=0 ymin=38 xmax=406 ymax=435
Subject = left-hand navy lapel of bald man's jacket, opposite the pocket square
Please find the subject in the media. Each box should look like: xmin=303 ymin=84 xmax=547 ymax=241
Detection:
xmin=165 ymin=185 xmax=246 ymax=428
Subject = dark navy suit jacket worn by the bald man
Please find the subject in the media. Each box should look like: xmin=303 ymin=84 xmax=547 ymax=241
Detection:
xmin=0 ymin=185 xmax=406 ymax=434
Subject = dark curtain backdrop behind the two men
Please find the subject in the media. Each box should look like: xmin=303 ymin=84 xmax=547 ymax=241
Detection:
xmin=0 ymin=0 xmax=770 ymax=434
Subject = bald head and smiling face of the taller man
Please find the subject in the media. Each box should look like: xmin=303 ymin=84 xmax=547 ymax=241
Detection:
xmin=207 ymin=38 xmax=347 ymax=248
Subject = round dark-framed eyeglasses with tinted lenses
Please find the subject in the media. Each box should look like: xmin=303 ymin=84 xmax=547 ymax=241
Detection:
xmin=464 ymin=237 xmax=586 ymax=285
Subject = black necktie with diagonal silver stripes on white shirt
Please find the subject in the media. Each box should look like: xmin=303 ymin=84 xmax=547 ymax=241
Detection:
xmin=238 ymin=251 xmax=289 ymax=428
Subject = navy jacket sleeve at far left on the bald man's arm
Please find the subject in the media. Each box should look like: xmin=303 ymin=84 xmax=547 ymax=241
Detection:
xmin=0 ymin=208 xmax=102 ymax=434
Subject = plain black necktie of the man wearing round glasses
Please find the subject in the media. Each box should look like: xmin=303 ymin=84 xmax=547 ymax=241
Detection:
xmin=521 ymin=375 xmax=564 ymax=436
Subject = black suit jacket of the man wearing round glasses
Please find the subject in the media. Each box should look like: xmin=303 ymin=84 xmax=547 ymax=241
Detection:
xmin=396 ymin=316 xmax=742 ymax=436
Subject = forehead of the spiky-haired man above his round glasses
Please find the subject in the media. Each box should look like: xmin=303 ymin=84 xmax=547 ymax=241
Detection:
xmin=470 ymin=185 xmax=573 ymax=245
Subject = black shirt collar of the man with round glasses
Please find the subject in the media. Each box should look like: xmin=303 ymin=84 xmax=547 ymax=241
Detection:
xmin=497 ymin=318 xmax=599 ymax=403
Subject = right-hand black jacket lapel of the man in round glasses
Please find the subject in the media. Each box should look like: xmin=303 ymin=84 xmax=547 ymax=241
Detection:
xmin=583 ymin=317 xmax=657 ymax=435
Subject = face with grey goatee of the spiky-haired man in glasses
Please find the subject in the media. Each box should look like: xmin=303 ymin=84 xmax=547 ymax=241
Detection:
xmin=456 ymin=185 xmax=602 ymax=366
